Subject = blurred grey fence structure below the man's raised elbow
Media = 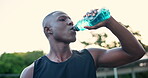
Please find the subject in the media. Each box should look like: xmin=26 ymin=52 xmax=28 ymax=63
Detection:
xmin=97 ymin=59 xmax=148 ymax=78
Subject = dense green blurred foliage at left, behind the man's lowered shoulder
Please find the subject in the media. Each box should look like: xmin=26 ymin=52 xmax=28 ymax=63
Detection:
xmin=0 ymin=51 xmax=44 ymax=74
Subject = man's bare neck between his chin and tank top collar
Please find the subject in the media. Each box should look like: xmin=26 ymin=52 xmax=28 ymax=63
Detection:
xmin=47 ymin=42 xmax=72 ymax=62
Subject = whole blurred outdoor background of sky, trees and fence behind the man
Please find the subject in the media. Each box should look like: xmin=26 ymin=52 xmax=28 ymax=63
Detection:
xmin=0 ymin=0 xmax=148 ymax=78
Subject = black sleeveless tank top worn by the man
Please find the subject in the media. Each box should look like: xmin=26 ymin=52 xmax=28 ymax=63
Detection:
xmin=33 ymin=49 xmax=96 ymax=78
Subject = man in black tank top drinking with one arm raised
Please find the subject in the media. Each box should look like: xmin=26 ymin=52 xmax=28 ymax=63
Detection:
xmin=20 ymin=10 xmax=145 ymax=78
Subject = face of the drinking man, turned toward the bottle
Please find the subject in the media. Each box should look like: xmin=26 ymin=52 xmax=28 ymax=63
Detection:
xmin=50 ymin=12 xmax=76 ymax=43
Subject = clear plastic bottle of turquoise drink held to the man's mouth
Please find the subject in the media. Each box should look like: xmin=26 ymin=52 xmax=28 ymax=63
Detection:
xmin=73 ymin=8 xmax=110 ymax=31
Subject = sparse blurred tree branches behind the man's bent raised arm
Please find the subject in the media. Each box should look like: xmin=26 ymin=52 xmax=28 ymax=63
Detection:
xmin=81 ymin=22 xmax=148 ymax=51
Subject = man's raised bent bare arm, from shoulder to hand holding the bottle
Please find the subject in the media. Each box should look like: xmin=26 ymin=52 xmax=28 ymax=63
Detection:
xmin=85 ymin=17 xmax=145 ymax=67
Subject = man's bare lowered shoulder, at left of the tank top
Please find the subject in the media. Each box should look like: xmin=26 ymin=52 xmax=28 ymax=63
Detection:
xmin=20 ymin=63 xmax=34 ymax=78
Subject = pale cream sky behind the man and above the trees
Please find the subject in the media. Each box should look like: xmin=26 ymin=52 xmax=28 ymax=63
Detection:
xmin=0 ymin=0 xmax=148 ymax=53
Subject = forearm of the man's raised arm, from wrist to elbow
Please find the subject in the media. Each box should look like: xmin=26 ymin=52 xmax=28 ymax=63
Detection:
xmin=106 ymin=17 xmax=145 ymax=58
